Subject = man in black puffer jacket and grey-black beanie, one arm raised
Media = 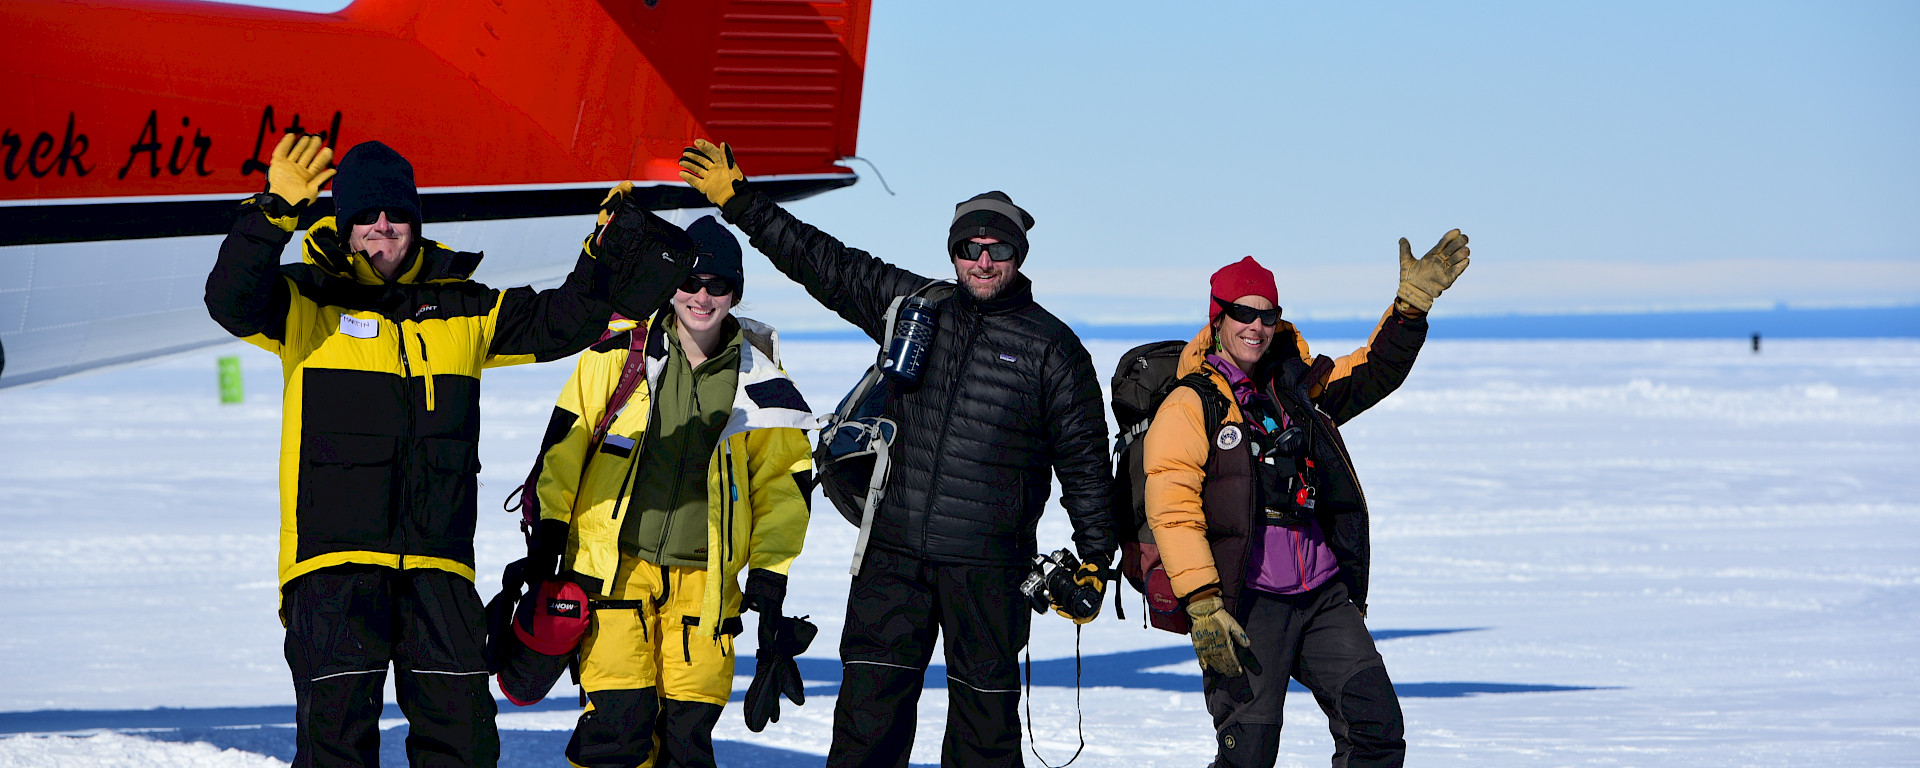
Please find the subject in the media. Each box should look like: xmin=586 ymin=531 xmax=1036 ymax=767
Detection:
xmin=680 ymin=140 xmax=1117 ymax=766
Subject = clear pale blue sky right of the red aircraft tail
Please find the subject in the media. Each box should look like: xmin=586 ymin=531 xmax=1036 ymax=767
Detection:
xmin=232 ymin=0 xmax=1920 ymax=328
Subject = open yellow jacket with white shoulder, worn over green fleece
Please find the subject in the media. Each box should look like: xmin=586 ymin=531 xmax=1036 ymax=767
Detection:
xmin=538 ymin=313 xmax=814 ymax=634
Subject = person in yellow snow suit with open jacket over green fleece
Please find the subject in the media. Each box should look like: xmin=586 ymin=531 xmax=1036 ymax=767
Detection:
xmin=526 ymin=217 xmax=812 ymax=768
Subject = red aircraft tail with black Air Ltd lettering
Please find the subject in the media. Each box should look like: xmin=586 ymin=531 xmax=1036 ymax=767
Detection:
xmin=0 ymin=0 xmax=870 ymax=246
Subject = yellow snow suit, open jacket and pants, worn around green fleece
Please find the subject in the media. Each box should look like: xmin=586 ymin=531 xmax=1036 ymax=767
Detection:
xmin=536 ymin=313 xmax=814 ymax=764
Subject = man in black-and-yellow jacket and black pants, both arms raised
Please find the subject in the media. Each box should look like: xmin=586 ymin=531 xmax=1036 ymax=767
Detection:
xmin=205 ymin=134 xmax=693 ymax=766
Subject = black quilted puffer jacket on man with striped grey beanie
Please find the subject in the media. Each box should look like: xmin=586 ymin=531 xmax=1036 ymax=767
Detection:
xmin=722 ymin=190 xmax=1117 ymax=564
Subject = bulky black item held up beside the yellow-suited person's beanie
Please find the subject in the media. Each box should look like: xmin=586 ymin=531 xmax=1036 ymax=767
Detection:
xmin=589 ymin=190 xmax=699 ymax=317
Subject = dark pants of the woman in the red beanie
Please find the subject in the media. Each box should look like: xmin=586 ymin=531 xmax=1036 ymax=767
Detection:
xmin=1206 ymin=580 xmax=1407 ymax=768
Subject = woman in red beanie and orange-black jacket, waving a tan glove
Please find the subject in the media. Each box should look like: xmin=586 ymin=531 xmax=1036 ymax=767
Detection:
xmin=1144 ymin=237 xmax=1469 ymax=768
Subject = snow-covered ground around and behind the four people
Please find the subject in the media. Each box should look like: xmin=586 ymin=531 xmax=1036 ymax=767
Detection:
xmin=0 ymin=340 xmax=1920 ymax=766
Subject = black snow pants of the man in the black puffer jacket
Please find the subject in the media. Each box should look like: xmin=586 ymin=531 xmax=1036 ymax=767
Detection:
xmin=828 ymin=549 xmax=1033 ymax=768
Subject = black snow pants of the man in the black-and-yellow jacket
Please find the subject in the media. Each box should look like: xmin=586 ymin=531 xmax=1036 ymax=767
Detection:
xmin=282 ymin=564 xmax=499 ymax=768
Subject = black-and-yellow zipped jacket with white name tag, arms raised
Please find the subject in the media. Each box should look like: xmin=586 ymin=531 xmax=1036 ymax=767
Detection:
xmin=205 ymin=209 xmax=611 ymax=586
